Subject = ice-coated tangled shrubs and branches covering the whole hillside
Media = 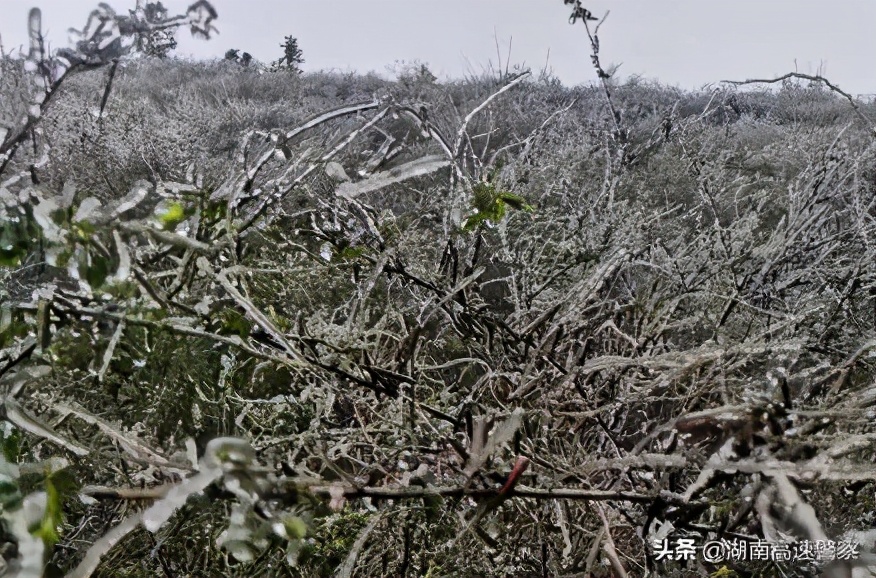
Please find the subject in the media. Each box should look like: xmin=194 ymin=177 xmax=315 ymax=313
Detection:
xmin=0 ymin=2 xmax=876 ymax=577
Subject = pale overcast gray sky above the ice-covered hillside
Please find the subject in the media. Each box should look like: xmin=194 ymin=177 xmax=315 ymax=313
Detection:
xmin=0 ymin=0 xmax=876 ymax=94
